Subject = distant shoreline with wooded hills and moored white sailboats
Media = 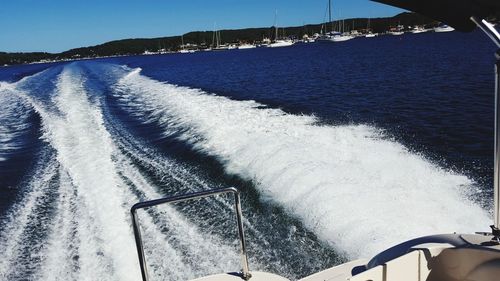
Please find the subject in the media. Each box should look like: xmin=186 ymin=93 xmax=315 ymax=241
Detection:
xmin=0 ymin=7 xmax=468 ymax=66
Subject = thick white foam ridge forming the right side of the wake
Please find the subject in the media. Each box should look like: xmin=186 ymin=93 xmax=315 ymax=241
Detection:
xmin=115 ymin=70 xmax=489 ymax=258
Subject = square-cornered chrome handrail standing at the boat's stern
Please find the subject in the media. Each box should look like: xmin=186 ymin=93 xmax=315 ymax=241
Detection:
xmin=130 ymin=187 xmax=252 ymax=281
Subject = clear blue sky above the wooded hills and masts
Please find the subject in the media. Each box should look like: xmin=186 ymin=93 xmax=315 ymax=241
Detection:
xmin=0 ymin=0 xmax=402 ymax=52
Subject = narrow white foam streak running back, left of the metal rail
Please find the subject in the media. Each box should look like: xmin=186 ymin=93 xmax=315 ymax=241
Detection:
xmin=29 ymin=67 xmax=140 ymax=280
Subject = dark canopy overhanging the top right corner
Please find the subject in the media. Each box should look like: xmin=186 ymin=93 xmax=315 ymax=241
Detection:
xmin=372 ymin=0 xmax=500 ymax=31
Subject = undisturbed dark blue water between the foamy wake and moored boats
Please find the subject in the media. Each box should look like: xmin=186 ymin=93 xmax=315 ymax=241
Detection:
xmin=112 ymin=32 xmax=495 ymax=186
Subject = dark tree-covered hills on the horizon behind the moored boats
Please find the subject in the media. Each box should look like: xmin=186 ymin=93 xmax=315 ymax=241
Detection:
xmin=0 ymin=12 xmax=488 ymax=66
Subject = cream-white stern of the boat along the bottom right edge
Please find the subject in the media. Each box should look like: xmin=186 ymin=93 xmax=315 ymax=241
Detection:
xmin=187 ymin=234 xmax=500 ymax=281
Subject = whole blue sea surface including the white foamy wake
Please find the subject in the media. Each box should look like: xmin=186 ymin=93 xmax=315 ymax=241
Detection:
xmin=0 ymin=31 xmax=495 ymax=281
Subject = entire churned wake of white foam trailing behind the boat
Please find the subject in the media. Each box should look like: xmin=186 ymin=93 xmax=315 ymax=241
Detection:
xmin=0 ymin=62 xmax=489 ymax=281
